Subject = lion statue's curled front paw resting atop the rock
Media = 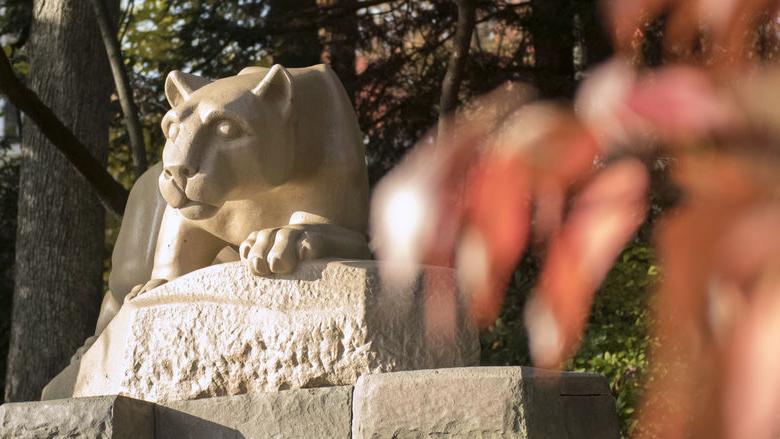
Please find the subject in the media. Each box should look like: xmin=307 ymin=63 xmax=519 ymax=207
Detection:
xmin=239 ymin=225 xmax=321 ymax=275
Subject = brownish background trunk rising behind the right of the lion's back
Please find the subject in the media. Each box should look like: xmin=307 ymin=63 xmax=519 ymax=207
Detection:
xmin=320 ymin=0 xmax=360 ymax=103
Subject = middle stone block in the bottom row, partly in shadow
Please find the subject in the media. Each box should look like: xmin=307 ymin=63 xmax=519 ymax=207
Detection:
xmin=155 ymin=386 xmax=352 ymax=439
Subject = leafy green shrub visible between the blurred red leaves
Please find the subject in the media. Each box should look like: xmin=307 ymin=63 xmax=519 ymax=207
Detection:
xmin=481 ymin=241 xmax=658 ymax=437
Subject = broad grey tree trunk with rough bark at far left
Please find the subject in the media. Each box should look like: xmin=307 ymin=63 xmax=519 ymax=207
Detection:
xmin=5 ymin=0 xmax=118 ymax=401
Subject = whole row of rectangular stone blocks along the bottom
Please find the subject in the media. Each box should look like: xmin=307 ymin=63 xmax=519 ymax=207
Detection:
xmin=0 ymin=367 xmax=619 ymax=439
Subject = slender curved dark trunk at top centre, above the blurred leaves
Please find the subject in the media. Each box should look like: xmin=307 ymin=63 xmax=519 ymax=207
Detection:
xmin=439 ymin=0 xmax=476 ymax=134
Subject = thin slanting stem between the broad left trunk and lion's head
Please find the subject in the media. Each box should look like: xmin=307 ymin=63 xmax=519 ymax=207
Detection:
xmin=90 ymin=0 xmax=147 ymax=176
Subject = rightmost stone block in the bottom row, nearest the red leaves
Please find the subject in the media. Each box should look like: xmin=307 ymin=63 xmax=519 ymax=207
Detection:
xmin=352 ymin=367 xmax=619 ymax=439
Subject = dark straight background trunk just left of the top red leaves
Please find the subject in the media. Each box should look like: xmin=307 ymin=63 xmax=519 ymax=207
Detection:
xmin=530 ymin=0 xmax=575 ymax=98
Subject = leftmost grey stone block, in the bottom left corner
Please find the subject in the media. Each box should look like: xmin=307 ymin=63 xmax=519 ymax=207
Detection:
xmin=0 ymin=396 xmax=154 ymax=439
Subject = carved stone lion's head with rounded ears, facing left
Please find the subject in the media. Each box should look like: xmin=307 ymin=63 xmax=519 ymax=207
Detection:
xmin=159 ymin=65 xmax=295 ymax=219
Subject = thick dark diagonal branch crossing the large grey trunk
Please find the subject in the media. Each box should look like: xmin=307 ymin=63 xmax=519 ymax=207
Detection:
xmin=0 ymin=49 xmax=128 ymax=217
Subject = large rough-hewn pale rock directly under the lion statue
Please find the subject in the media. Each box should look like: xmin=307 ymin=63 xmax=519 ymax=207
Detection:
xmin=74 ymin=261 xmax=479 ymax=402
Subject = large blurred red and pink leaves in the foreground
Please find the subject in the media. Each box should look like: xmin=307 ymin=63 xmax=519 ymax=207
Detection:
xmin=372 ymin=0 xmax=780 ymax=439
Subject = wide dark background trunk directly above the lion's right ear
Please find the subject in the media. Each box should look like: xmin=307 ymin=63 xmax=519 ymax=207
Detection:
xmin=268 ymin=0 xmax=322 ymax=67
